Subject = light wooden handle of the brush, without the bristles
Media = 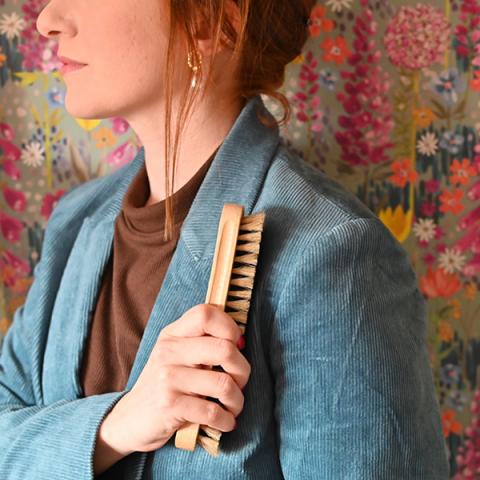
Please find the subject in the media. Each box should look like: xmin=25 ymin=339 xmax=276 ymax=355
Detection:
xmin=175 ymin=203 xmax=243 ymax=451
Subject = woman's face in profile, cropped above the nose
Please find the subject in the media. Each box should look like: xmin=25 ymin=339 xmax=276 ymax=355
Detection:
xmin=37 ymin=0 xmax=187 ymax=119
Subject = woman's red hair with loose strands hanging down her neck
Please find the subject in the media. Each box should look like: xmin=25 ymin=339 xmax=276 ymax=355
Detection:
xmin=159 ymin=0 xmax=316 ymax=240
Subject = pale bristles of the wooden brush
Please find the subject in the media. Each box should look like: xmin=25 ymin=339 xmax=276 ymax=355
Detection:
xmin=197 ymin=212 xmax=265 ymax=457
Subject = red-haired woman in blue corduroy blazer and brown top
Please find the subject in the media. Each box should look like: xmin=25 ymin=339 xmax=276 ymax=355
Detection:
xmin=0 ymin=0 xmax=448 ymax=480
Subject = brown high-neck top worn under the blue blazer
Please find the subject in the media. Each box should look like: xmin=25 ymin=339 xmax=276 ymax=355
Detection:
xmin=80 ymin=152 xmax=216 ymax=397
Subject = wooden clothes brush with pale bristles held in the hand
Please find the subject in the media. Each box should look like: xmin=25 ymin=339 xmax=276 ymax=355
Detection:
xmin=175 ymin=203 xmax=265 ymax=457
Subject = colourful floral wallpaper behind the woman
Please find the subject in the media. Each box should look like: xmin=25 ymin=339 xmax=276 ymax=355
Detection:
xmin=0 ymin=0 xmax=480 ymax=479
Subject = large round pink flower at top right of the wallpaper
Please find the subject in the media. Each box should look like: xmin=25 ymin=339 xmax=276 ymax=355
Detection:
xmin=384 ymin=4 xmax=450 ymax=70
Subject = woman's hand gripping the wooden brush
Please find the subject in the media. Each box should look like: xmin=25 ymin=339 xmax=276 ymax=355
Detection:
xmin=98 ymin=304 xmax=251 ymax=454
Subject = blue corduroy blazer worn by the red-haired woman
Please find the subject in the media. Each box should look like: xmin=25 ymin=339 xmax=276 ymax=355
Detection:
xmin=0 ymin=96 xmax=448 ymax=480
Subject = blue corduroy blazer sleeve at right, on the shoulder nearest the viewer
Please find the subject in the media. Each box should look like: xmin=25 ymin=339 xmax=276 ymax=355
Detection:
xmin=270 ymin=218 xmax=449 ymax=480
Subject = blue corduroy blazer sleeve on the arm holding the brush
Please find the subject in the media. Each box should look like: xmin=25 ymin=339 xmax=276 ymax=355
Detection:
xmin=0 ymin=193 xmax=127 ymax=480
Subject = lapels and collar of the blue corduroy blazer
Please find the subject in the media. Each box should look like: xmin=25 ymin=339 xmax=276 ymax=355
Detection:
xmin=45 ymin=96 xmax=280 ymax=401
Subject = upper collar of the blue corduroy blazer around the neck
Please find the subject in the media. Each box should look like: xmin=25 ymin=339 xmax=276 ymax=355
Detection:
xmin=92 ymin=95 xmax=280 ymax=260
